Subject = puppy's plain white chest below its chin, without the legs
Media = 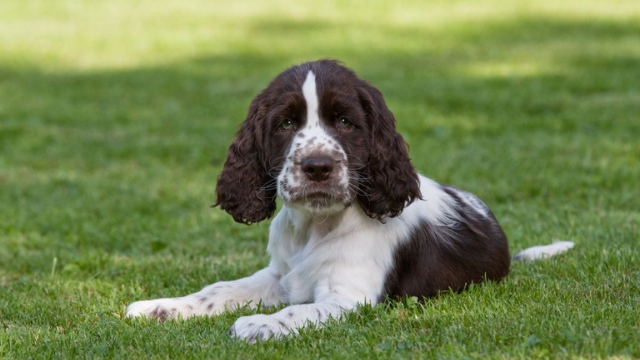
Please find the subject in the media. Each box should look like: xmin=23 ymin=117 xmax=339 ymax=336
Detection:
xmin=268 ymin=207 xmax=406 ymax=304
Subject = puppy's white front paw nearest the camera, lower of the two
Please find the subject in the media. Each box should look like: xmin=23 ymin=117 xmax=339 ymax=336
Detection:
xmin=229 ymin=315 xmax=293 ymax=344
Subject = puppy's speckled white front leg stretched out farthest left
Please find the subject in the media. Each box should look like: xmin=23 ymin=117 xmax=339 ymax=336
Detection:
xmin=126 ymin=267 xmax=284 ymax=321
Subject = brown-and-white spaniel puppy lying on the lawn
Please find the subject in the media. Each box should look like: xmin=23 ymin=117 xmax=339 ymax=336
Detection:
xmin=126 ymin=60 xmax=573 ymax=342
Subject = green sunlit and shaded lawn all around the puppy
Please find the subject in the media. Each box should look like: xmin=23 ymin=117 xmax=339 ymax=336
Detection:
xmin=0 ymin=0 xmax=640 ymax=359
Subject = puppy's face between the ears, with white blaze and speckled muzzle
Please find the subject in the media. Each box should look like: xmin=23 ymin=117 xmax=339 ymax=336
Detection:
xmin=273 ymin=70 xmax=369 ymax=213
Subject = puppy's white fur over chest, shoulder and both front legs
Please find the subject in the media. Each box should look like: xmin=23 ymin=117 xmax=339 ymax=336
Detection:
xmin=127 ymin=176 xmax=450 ymax=342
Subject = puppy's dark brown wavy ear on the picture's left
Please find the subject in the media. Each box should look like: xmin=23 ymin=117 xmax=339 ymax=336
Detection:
xmin=213 ymin=94 xmax=276 ymax=224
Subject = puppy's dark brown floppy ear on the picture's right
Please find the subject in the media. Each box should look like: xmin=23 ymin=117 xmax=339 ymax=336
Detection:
xmin=358 ymin=83 xmax=421 ymax=221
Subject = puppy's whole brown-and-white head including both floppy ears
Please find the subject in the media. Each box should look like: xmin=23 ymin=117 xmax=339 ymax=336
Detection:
xmin=216 ymin=60 xmax=420 ymax=223
